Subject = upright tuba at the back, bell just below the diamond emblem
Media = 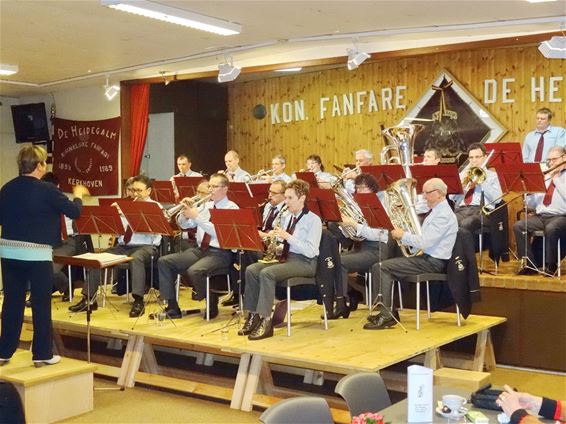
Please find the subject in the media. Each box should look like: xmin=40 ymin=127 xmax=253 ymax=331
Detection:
xmin=381 ymin=124 xmax=424 ymax=177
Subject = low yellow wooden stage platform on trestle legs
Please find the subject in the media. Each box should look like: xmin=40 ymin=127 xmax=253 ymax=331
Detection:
xmin=8 ymin=289 xmax=506 ymax=411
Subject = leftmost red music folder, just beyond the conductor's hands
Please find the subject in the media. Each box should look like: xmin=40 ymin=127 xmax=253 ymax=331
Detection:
xmin=75 ymin=205 xmax=125 ymax=235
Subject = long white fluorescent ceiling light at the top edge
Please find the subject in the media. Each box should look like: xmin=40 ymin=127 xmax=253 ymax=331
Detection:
xmin=100 ymin=0 xmax=242 ymax=35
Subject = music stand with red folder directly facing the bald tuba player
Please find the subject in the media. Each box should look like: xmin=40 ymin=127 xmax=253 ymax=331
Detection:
xmin=354 ymin=193 xmax=407 ymax=333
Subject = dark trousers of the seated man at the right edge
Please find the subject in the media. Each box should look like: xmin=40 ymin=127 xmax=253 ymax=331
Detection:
xmin=513 ymin=215 xmax=566 ymax=265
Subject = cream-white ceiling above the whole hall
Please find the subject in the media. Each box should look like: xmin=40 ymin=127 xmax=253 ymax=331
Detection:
xmin=0 ymin=0 xmax=566 ymax=97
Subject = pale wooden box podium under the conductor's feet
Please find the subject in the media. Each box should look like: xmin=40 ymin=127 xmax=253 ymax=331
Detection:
xmin=0 ymin=351 xmax=96 ymax=423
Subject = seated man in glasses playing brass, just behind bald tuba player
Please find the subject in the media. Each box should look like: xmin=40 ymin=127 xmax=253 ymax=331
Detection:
xmin=453 ymin=143 xmax=502 ymax=234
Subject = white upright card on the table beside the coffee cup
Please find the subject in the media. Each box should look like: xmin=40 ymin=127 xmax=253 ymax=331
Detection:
xmin=407 ymin=365 xmax=433 ymax=423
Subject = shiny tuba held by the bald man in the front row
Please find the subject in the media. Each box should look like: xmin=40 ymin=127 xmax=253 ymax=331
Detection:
xmin=385 ymin=178 xmax=422 ymax=257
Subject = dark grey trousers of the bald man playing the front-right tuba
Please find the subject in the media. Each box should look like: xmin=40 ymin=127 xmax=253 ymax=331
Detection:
xmin=371 ymin=255 xmax=447 ymax=307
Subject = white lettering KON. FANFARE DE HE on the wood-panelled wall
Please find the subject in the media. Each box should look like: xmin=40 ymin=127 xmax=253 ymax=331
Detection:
xmin=268 ymin=76 xmax=564 ymax=125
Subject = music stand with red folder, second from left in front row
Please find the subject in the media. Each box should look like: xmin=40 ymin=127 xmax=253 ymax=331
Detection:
xmin=117 ymin=202 xmax=174 ymax=328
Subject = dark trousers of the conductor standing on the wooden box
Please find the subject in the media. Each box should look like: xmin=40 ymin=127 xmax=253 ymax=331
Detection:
xmin=0 ymin=259 xmax=53 ymax=360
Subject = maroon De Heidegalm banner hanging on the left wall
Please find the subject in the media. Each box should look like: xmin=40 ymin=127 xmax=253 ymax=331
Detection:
xmin=53 ymin=117 xmax=120 ymax=196
